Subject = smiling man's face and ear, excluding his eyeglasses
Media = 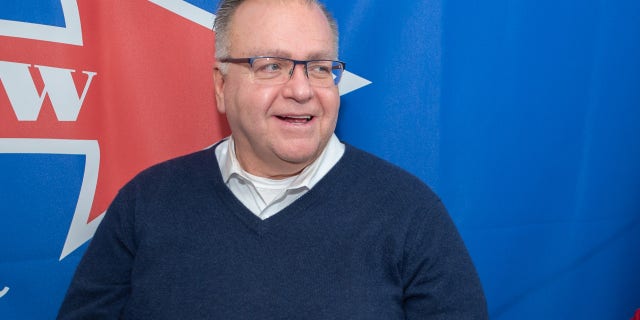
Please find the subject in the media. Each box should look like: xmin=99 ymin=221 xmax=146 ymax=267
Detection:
xmin=215 ymin=0 xmax=340 ymax=178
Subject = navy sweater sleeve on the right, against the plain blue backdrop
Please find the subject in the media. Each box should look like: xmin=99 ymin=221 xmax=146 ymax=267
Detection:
xmin=402 ymin=200 xmax=488 ymax=320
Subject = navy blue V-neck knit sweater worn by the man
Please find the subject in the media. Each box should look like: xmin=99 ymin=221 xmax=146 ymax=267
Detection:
xmin=59 ymin=146 xmax=487 ymax=320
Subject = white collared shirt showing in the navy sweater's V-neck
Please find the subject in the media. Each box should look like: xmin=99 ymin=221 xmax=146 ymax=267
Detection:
xmin=216 ymin=134 xmax=345 ymax=220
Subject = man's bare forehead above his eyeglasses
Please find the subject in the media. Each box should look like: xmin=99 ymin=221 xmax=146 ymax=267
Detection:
xmin=229 ymin=0 xmax=335 ymax=59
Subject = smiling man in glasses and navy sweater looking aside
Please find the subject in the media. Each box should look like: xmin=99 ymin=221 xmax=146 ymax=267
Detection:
xmin=59 ymin=0 xmax=487 ymax=320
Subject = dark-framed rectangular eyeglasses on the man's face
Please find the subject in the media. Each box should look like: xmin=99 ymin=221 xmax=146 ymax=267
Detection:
xmin=220 ymin=57 xmax=346 ymax=87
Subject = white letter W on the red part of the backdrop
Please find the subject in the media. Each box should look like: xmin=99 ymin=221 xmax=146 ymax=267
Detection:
xmin=0 ymin=61 xmax=96 ymax=121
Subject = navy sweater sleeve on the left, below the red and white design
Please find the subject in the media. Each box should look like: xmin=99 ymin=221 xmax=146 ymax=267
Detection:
xmin=57 ymin=184 xmax=135 ymax=320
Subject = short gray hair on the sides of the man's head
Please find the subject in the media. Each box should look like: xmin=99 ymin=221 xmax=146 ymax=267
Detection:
xmin=213 ymin=0 xmax=338 ymax=59
